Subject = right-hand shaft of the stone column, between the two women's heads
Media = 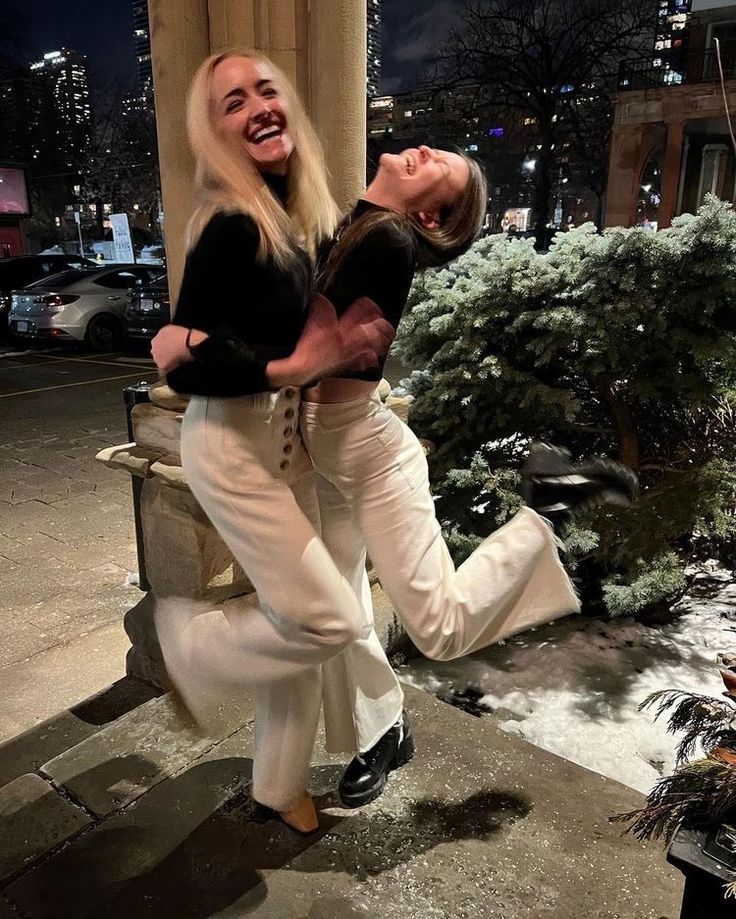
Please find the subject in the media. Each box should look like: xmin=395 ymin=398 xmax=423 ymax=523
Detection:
xmin=309 ymin=0 xmax=367 ymax=207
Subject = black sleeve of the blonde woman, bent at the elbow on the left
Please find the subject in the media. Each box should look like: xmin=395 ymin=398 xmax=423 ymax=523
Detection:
xmin=166 ymin=214 xmax=284 ymax=396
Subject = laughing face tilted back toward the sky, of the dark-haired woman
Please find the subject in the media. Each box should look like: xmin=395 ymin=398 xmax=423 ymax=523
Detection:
xmin=376 ymin=146 xmax=470 ymax=226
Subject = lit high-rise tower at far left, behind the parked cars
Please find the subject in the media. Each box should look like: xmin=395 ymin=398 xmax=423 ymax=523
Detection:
xmin=30 ymin=48 xmax=92 ymax=165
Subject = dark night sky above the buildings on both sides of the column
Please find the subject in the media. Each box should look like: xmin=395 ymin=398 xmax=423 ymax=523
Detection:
xmin=2 ymin=0 xmax=465 ymax=93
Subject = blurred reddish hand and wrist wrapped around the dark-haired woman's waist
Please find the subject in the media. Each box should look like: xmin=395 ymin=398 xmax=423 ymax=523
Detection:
xmin=267 ymin=294 xmax=395 ymax=387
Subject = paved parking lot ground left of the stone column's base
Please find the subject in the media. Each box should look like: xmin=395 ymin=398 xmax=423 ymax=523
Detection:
xmin=0 ymin=344 xmax=156 ymax=741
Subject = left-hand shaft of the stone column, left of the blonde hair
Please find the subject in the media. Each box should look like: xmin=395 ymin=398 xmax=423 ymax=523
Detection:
xmin=148 ymin=0 xmax=210 ymax=302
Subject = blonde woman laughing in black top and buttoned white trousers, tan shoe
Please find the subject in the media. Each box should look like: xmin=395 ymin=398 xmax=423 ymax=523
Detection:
xmin=153 ymin=52 xmax=393 ymax=830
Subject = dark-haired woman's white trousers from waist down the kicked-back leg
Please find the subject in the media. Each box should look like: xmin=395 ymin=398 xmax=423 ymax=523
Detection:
xmin=300 ymin=395 xmax=580 ymax=660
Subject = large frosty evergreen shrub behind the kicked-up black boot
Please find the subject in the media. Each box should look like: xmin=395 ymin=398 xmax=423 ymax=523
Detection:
xmin=397 ymin=198 xmax=736 ymax=614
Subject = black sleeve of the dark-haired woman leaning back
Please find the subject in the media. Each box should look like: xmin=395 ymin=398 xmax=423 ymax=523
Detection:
xmin=325 ymin=225 xmax=416 ymax=329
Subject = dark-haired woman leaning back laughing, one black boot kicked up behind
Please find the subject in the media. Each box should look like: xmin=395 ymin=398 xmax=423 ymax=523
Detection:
xmin=155 ymin=48 xmax=640 ymax=828
